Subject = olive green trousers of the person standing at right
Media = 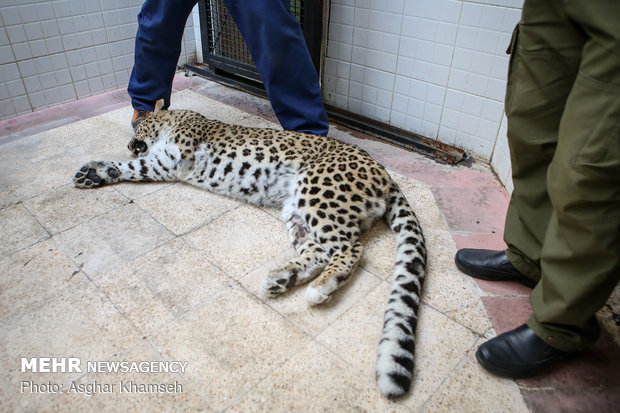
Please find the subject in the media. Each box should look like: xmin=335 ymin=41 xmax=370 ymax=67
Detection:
xmin=504 ymin=0 xmax=620 ymax=352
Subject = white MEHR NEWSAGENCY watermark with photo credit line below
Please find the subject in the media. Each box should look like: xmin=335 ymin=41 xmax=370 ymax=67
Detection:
xmin=19 ymin=357 xmax=187 ymax=396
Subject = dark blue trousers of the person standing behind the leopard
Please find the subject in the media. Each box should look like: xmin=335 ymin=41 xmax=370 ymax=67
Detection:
xmin=127 ymin=0 xmax=329 ymax=135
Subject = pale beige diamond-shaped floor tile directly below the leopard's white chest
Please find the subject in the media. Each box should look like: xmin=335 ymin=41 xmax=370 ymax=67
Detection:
xmin=136 ymin=183 xmax=239 ymax=235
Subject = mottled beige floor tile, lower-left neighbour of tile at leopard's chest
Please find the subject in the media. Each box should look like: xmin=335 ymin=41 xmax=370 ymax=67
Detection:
xmin=54 ymin=204 xmax=174 ymax=277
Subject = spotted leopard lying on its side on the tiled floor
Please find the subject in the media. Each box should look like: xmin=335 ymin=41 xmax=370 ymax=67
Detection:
xmin=73 ymin=100 xmax=426 ymax=397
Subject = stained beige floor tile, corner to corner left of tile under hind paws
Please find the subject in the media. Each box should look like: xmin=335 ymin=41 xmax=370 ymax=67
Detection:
xmin=95 ymin=239 xmax=232 ymax=335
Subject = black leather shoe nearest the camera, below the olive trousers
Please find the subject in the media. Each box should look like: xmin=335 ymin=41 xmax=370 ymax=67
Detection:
xmin=476 ymin=324 xmax=570 ymax=379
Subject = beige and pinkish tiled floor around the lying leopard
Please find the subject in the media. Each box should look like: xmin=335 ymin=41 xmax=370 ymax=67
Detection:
xmin=0 ymin=75 xmax=620 ymax=412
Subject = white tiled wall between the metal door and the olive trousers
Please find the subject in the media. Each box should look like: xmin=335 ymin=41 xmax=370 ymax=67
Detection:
xmin=323 ymin=0 xmax=523 ymax=186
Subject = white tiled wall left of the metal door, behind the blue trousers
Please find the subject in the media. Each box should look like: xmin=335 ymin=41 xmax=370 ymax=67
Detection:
xmin=0 ymin=0 xmax=196 ymax=119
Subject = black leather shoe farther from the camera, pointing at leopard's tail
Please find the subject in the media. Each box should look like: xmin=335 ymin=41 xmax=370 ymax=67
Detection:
xmin=454 ymin=248 xmax=537 ymax=288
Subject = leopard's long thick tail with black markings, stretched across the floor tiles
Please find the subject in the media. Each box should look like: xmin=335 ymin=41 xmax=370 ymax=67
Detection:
xmin=376 ymin=183 xmax=426 ymax=398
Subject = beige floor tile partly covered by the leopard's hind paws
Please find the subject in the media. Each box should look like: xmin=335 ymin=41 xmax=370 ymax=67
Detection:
xmin=241 ymin=249 xmax=381 ymax=336
